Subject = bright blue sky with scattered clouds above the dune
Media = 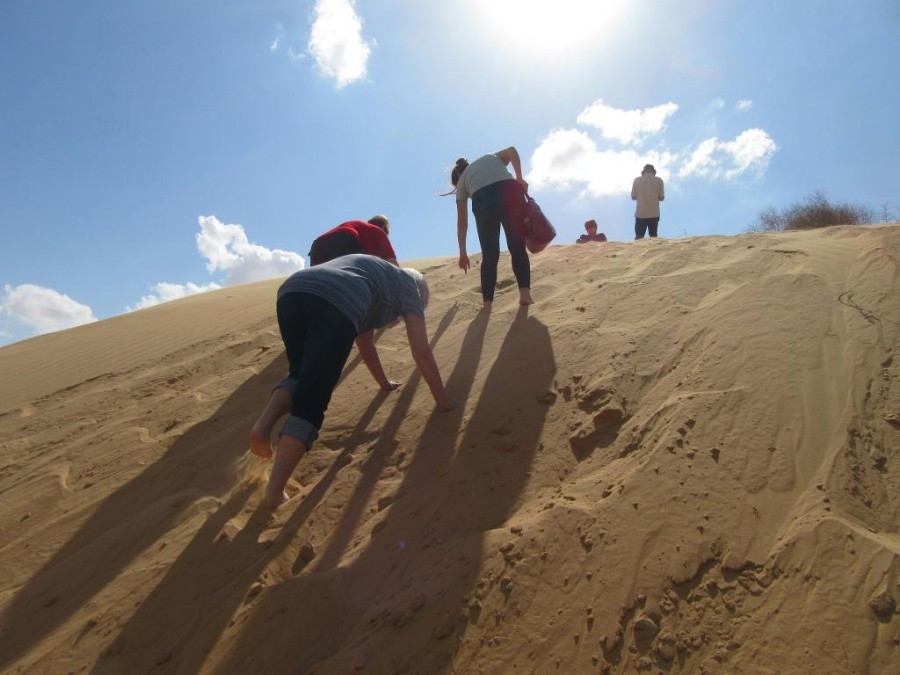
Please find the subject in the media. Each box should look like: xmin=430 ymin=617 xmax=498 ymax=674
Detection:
xmin=0 ymin=0 xmax=900 ymax=345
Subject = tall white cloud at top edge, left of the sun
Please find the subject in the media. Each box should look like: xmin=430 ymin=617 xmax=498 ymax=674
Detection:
xmin=308 ymin=0 xmax=372 ymax=89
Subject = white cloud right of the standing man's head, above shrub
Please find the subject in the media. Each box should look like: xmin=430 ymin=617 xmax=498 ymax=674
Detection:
xmin=678 ymin=129 xmax=778 ymax=180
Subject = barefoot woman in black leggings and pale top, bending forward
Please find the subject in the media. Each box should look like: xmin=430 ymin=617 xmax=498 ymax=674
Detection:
xmin=447 ymin=146 xmax=534 ymax=310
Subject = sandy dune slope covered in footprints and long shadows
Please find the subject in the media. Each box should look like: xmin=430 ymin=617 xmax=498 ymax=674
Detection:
xmin=0 ymin=226 xmax=900 ymax=674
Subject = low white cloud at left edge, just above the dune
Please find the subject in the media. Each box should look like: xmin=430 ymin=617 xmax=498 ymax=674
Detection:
xmin=0 ymin=284 xmax=97 ymax=335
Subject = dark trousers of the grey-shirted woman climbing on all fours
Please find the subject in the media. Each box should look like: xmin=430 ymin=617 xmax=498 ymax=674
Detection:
xmin=276 ymin=293 xmax=356 ymax=429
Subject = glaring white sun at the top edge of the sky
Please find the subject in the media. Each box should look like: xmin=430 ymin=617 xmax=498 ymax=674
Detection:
xmin=478 ymin=0 xmax=625 ymax=56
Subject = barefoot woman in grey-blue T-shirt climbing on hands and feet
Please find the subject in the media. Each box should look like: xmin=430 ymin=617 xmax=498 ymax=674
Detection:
xmin=250 ymin=255 xmax=453 ymax=508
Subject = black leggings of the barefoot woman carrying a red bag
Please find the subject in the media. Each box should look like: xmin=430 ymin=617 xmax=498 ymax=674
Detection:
xmin=472 ymin=180 xmax=531 ymax=302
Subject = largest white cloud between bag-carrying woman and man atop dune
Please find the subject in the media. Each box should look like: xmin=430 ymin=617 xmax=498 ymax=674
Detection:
xmin=527 ymin=129 xmax=675 ymax=197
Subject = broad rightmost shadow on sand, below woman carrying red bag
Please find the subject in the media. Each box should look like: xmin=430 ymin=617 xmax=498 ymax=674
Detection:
xmin=207 ymin=309 xmax=555 ymax=673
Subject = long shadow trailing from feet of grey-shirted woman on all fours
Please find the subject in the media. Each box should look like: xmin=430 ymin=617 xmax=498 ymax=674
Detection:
xmin=82 ymin=308 xmax=464 ymax=675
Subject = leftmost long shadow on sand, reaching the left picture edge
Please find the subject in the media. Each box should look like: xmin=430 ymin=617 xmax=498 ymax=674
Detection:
xmin=0 ymin=357 xmax=286 ymax=670
